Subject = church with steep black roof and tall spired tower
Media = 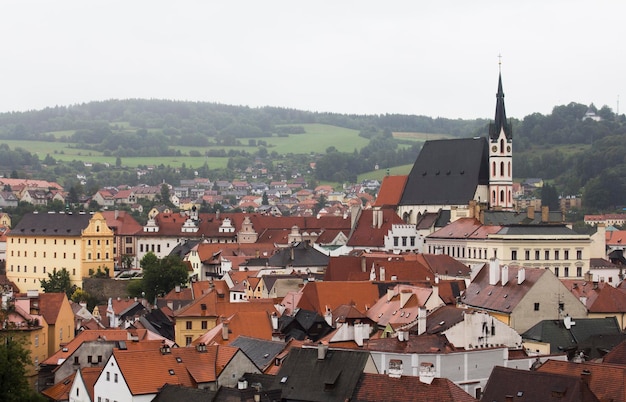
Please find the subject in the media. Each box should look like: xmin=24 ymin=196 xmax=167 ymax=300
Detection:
xmin=394 ymin=70 xmax=513 ymax=224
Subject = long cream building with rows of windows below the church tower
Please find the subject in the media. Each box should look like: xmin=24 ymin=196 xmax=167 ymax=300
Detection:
xmin=424 ymin=204 xmax=595 ymax=278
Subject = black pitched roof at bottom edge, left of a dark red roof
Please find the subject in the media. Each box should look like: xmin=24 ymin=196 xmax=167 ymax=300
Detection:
xmin=276 ymin=348 xmax=369 ymax=401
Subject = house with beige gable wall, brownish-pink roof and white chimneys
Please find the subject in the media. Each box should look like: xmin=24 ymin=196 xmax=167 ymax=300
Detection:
xmin=460 ymin=259 xmax=587 ymax=333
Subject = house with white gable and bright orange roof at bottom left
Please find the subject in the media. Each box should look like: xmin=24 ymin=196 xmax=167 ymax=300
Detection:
xmin=94 ymin=345 xmax=259 ymax=402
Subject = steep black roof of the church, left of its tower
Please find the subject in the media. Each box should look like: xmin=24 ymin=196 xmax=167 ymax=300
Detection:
xmin=400 ymin=137 xmax=489 ymax=205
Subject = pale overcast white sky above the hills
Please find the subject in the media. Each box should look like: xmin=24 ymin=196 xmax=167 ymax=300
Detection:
xmin=0 ymin=0 xmax=626 ymax=119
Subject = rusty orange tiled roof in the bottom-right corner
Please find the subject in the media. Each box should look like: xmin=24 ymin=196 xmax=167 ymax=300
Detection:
xmin=537 ymin=360 xmax=626 ymax=401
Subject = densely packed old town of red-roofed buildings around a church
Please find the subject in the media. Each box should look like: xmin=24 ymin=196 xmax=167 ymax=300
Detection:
xmin=0 ymin=73 xmax=626 ymax=402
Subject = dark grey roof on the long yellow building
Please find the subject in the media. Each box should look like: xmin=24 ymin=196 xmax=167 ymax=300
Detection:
xmin=8 ymin=213 xmax=91 ymax=237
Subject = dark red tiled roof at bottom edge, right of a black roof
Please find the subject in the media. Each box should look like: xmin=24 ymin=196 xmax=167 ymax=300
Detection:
xmin=350 ymin=373 xmax=476 ymax=402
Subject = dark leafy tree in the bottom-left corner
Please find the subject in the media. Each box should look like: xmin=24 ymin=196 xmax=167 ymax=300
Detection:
xmin=0 ymin=332 xmax=45 ymax=402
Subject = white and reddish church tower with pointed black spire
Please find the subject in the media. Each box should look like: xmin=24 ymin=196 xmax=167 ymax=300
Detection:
xmin=489 ymin=70 xmax=513 ymax=210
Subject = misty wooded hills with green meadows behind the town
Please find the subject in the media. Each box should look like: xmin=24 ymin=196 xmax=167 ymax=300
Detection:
xmin=0 ymin=99 xmax=626 ymax=211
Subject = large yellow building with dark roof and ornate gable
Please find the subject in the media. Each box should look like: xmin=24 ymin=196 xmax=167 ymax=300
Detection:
xmin=6 ymin=212 xmax=114 ymax=291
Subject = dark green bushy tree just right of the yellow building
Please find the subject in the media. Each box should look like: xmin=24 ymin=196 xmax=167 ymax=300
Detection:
xmin=139 ymin=252 xmax=189 ymax=300
